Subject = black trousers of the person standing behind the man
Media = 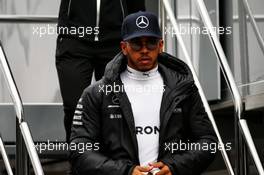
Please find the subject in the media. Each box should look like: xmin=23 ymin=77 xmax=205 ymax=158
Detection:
xmin=56 ymin=37 xmax=120 ymax=142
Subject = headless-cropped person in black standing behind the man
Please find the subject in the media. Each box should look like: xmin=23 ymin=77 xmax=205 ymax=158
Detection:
xmin=56 ymin=0 xmax=145 ymax=142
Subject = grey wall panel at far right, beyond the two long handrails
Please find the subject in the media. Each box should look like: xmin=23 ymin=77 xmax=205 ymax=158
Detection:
xmin=233 ymin=0 xmax=264 ymax=96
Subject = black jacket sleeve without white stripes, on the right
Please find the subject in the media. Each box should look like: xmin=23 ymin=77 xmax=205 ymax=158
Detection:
xmin=161 ymin=87 xmax=217 ymax=175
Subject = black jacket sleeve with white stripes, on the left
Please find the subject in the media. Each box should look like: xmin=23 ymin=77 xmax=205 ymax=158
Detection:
xmin=70 ymin=88 xmax=133 ymax=175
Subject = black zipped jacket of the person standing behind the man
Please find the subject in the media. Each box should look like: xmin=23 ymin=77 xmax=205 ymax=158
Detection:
xmin=58 ymin=0 xmax=145 ymax=42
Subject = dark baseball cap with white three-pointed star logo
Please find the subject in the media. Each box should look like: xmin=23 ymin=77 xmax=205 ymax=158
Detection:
xmin=121 ymin=11 xmax=162 ymax=41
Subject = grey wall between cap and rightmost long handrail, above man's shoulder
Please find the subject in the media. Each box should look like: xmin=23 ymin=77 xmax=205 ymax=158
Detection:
xmin=162 ymin=0 xmax=220 ymax=100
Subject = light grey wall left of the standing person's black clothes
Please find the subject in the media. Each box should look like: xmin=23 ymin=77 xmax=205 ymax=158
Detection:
xmin=0 ymin=0 xmax=61 ymax=103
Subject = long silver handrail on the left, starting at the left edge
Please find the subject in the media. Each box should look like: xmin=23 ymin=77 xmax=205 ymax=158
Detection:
xmin=0 ymin=43 xmax=44 ymax=175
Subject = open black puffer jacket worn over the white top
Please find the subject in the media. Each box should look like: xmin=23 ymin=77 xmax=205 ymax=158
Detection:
xmin=70 ymin=53 xmax=216 ymax=175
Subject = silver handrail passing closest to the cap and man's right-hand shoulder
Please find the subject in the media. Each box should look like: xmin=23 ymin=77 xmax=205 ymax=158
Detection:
xmin=160 ymin=0 xmax=234 ymax=175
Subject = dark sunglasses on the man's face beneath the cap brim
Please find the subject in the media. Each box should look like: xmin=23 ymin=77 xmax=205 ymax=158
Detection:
xmin=128 ymin=38 xmax=160 ymax=51
